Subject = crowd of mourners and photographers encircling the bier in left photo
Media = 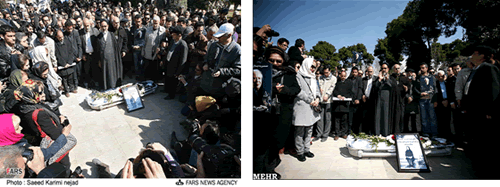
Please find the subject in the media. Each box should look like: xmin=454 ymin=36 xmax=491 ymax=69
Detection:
xmin=0 ymin=0 xmax=241 ymax=178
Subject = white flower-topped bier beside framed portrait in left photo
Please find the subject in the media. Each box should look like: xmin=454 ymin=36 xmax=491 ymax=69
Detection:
xmin=85 ymin=81 xmax=158 ymax=110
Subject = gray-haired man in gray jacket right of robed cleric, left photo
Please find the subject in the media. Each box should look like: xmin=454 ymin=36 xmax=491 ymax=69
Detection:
xmin=141 ymin=16 xmax=167 ymax=81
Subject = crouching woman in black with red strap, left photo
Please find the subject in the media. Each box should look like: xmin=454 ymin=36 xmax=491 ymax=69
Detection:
xmin=14 ymin=79 xmax=76 ymax=168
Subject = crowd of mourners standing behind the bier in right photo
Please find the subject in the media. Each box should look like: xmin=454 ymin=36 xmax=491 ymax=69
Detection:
xmin=253 ymin=25 xmax=500 ymax=178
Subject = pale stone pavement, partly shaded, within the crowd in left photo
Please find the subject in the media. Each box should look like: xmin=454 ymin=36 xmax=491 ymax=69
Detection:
xmin=60 ymin=80 xmax=187 ymax=178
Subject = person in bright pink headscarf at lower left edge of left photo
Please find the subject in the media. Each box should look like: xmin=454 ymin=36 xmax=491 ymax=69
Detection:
xmin=0 ymin=114 xmax=71 ymax=165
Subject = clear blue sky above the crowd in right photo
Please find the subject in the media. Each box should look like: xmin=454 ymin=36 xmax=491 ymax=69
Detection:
xmin=253 ymin=0 xmax=462 ymax=60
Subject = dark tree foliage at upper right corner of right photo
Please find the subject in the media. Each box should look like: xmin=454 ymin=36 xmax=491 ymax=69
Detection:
xmin=380 ymin=0 xmax=500 ymax=71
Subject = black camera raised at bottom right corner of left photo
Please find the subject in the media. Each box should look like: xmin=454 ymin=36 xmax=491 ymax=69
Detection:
xmin=188 ymin=134 xmax=240 ymax=178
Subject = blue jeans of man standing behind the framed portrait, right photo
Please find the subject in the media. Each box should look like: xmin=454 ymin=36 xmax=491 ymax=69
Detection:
xmin=420 ymin=99 xmax=438 ymax=136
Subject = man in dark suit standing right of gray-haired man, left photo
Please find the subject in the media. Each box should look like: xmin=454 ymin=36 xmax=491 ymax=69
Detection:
xmin=163 ymin=26 xmax=189 ymax=100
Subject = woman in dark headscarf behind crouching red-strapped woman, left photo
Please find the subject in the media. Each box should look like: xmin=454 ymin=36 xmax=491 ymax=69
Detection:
xmin=32 ymin=61 xmax=62 ymax=114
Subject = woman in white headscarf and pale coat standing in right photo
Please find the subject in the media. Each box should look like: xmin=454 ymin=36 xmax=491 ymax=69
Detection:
xmin=293 ymin=58 xmax=321 ymax=162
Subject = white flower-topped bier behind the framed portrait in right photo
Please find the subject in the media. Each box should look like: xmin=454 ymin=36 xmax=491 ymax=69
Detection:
xmin=346 ymin=133 xmax=455 ymax=158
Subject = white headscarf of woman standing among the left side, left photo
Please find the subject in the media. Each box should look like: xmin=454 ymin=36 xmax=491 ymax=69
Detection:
xmin=30 ymin=46 xmax=62 ymax=88
